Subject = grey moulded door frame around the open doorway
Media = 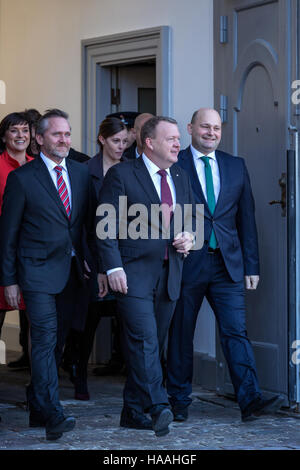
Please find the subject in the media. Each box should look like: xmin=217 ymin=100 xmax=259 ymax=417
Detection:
xmin=81 ymin=26 xmax=173 ymax=156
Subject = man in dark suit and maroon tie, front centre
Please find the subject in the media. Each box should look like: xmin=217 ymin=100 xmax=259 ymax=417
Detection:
xmin=97 ymin=117 xmax=193 ymax=436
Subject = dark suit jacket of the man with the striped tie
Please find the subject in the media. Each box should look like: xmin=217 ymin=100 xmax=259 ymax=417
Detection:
xmin=0 ymin=157 xmax=95 ymax=294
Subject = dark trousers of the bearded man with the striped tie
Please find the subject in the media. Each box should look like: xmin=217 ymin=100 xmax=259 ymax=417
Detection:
xmin=23 ymin=263 xmax=79 ymax=426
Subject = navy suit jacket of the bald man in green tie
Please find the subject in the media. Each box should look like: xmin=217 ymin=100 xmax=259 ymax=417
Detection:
xmin=178 ymin=147 xmax=259 ymax=282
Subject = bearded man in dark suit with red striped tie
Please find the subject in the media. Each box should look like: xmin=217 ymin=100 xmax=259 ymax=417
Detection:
xmin=1 ymin=110 xmax=94 ymax=440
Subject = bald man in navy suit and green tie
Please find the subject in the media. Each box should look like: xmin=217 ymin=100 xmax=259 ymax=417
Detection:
xmin=167 ymin=108 xmax=283 ymax=421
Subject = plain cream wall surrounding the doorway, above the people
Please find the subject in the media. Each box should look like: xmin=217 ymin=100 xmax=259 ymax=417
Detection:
xmin=0 ymin=0 xmax=213 ymax=149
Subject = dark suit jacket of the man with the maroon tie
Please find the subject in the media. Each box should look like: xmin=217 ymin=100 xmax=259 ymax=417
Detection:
xmin=97 ymin=157 xmax=193 ymax=300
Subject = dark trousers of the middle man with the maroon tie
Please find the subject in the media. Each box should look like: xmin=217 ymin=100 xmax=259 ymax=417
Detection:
xmin=117 ymin=265 xmax=175 ymax=413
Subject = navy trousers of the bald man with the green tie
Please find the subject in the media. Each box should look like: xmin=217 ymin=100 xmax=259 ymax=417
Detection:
xmin=167 ymin=252 xmax=261 ymax=410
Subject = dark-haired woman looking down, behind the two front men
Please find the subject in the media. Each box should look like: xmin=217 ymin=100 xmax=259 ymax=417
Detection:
xmin=64 ymin=118 xmax=128 ymax=400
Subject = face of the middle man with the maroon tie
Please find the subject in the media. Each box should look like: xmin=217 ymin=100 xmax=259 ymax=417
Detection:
xmin=146 ymin=121 xmax=180 ymax=170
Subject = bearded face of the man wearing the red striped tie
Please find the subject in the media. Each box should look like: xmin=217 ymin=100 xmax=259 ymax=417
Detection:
xmin=36 ymin=117 xmax=71 ymax=162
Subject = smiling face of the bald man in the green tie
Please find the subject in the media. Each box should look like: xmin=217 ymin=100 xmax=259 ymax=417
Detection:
xmin=188 ymin=109 xmax=222 ymax=155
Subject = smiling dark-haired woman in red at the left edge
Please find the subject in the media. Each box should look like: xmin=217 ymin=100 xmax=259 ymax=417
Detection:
xmin=0 ymin=113 xmax=32 ymax=368
